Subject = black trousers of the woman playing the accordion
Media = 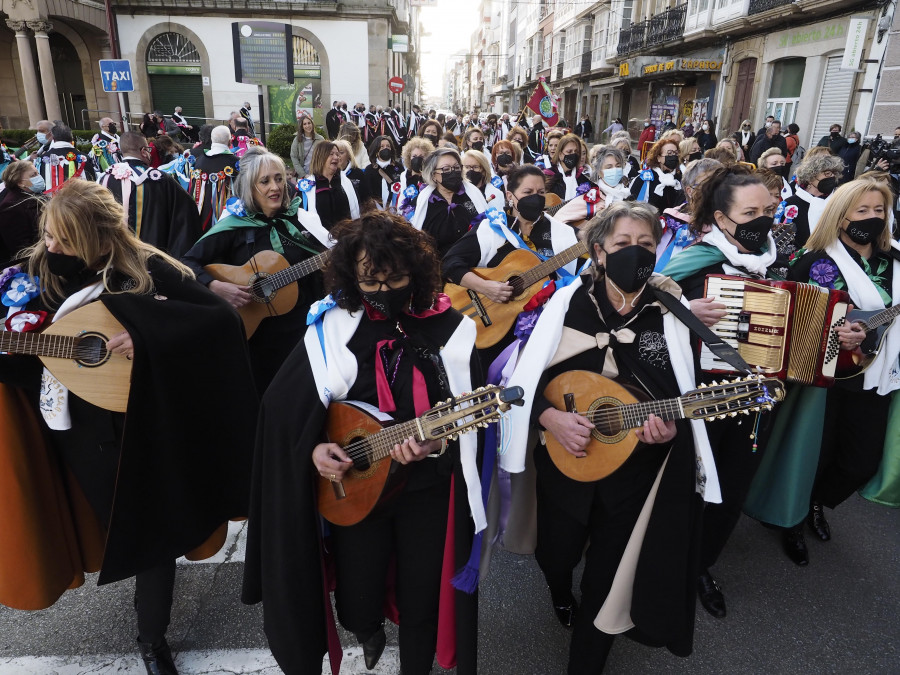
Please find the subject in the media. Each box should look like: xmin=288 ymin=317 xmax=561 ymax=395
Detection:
xmin=700 ymin=414 xmax=772 ymax=570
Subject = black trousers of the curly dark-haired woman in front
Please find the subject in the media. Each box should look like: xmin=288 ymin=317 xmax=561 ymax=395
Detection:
xmin=331 ymin=478 xmax=450 ymax=675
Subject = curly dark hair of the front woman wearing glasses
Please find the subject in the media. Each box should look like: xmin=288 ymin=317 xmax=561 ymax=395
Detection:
xmin=325 ymin=211 xmax=442 ymax=312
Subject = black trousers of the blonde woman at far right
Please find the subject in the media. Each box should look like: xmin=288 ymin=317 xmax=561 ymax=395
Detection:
xmin=812 ymin=386 xmax=891 ymax=509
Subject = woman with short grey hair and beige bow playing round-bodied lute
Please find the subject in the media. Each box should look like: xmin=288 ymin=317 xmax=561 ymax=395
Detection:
xmin=501 ymin=202 xmax=718 ymax=675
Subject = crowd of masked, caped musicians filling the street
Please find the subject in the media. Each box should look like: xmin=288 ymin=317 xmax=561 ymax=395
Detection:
xmin=0 ymin=101 xmax=900 ymax=675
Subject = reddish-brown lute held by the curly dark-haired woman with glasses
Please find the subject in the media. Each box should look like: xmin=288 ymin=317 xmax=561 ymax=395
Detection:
xmin=318 ymin=385 xmax=525 ymax=525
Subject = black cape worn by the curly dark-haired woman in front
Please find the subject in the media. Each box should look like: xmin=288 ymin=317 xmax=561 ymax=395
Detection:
xmin=241 ymin=310 xmax=481 ymax=675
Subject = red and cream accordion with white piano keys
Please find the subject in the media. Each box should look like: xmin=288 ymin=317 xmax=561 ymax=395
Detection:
xmin=700 ymin=274 xmax=850 ymax=387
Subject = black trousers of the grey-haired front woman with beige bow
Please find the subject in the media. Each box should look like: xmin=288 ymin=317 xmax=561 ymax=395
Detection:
xmin=535 ymin=446 xmax=668 ymax=675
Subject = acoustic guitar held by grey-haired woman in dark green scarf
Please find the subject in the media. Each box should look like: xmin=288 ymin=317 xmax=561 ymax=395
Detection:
xmin=203 ymin=250 xmax=331 ymax=339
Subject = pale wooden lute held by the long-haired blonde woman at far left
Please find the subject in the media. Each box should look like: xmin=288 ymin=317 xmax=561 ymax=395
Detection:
xmin=0 ymin=302 xmax=131 ymax=412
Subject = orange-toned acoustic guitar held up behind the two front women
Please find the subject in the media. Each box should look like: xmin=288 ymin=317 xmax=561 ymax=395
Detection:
xmin=444 ymin=242 xmax=588 ymax=349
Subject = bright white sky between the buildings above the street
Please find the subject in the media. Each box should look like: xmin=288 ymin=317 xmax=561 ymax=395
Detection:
xmin=419 ymin=0 xmax=479 ymax=102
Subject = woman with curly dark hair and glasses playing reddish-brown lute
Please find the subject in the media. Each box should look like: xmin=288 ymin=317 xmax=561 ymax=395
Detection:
xmin=243 ymin=211 xmax=485 ymax=675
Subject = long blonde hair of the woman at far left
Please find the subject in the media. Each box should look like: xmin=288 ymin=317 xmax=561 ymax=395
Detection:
xmin=26 ymin=180 xmax=194 ymax=300
